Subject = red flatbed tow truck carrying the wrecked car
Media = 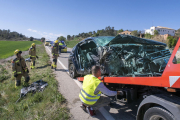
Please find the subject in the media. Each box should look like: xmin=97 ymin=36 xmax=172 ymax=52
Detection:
xmin=77 ymin=38 xmax=180 ymax=120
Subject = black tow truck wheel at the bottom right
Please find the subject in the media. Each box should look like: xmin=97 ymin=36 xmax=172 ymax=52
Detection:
xmin=143 ymin=107 xmax=175 ymax=120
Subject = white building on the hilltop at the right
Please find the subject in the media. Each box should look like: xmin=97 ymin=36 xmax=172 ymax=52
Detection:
xmin=145 ymin=26 xmax=175 ymax=36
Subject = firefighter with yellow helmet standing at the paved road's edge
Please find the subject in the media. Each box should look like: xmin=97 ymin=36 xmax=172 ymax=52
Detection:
xmin=51 ymin=40 xmax=59 ymax=70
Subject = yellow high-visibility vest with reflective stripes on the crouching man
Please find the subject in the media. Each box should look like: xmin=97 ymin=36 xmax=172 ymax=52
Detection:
xmin=79 ymin=75 xmax=101 ymax=105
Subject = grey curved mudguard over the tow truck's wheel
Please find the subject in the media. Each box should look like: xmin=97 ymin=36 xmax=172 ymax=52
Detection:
xmin=136 ymin=94 xmax=180 ymax=120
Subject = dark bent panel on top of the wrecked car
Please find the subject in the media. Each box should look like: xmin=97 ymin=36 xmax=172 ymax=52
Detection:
xmin=106 ymin=35 xmax=166 ymax=46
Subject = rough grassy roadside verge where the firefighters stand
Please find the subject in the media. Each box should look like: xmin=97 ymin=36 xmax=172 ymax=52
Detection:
xmin=0 ymin=45 xmax=70 ymax=120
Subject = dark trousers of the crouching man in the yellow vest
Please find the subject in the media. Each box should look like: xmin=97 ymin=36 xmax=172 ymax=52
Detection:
xmin=84 ymin=96 xmax=111 ymax=110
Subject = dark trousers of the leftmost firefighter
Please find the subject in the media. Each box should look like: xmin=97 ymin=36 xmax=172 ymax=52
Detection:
xmin=16 ymin=72 xmax=30 ymax=86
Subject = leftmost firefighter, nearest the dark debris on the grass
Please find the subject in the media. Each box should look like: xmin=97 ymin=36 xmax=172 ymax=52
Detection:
xmin=12 ymin=49 xmax=30 ymax=88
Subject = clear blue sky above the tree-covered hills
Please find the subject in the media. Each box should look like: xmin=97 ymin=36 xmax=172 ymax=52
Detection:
xmin=0 ymin=0 xmax=180 ymax=40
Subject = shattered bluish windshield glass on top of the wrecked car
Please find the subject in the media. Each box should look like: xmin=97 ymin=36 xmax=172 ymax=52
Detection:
xmin=94 ymin=36 xmax=115 ymax=46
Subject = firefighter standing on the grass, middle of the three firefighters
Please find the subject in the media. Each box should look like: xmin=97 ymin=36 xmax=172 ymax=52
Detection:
xmin=29 ymin=43 xmax=38 ymax=69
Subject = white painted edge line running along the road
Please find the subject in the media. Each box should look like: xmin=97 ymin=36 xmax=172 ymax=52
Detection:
xmin=47 ymin=47 xmax=115 ymax=120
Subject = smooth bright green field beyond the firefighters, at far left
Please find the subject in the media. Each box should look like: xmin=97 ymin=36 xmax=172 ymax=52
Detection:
xmin=0 ymin=41 xmax=42 ymax=59
